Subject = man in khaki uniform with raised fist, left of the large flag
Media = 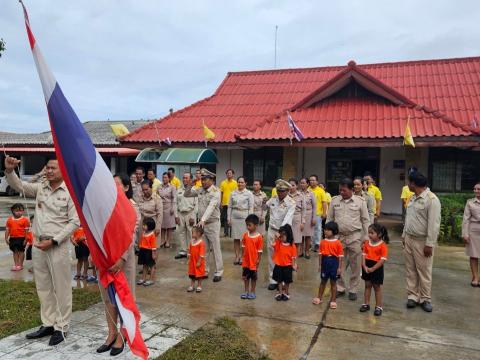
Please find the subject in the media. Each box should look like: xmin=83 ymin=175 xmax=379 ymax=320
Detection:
xmin=5 ymin=156 xmax=80 ymax=346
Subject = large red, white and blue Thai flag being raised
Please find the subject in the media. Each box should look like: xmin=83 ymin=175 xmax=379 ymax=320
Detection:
xmin=22 ymin=3 xmax=148 ymax=359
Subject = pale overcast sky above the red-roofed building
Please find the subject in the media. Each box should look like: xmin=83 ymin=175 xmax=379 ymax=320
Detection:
xmin=0 ymin=0 xmax=480 ymax=132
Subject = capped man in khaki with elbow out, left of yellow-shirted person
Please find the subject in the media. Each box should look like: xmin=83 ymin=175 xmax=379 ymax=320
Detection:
xmin=183 ymin=169 xmax=223 ymax=282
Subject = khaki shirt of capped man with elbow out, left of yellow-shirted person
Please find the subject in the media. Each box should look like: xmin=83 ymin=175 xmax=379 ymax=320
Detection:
xmin=183 ymin=185 xmax=220 ymax=223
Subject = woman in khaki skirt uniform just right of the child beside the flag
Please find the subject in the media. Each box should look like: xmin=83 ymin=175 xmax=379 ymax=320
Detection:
xmin=157 ymin=172 xmax=177 ymax=248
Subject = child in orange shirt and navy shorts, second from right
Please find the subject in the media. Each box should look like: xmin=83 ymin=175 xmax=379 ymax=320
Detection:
xmin=312 ymin=221 xmax=343 ymax=309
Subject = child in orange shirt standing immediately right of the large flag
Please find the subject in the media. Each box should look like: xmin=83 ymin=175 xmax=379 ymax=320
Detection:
xmin=137 ymin=218 xmax=157 ymax=286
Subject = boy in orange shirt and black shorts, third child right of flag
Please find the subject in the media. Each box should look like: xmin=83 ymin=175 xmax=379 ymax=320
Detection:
xmin=240 ymin=214 xmax=263 ymax=300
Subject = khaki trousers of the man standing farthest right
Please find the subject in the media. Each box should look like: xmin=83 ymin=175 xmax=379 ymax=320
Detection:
xmin=403 ymin=235 xmax=433 ymax=303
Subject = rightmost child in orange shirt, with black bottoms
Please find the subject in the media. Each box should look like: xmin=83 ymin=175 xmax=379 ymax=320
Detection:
xmin=360 ymin=223 xmax=389 ymax=316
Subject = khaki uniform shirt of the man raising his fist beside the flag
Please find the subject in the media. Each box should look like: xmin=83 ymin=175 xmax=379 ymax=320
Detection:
xmin=6 ymin=171 xmax=80 ymax=244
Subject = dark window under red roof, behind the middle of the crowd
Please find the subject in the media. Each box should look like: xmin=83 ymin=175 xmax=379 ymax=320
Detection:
xmin=243 ymin=147 xmax=283 ymax=186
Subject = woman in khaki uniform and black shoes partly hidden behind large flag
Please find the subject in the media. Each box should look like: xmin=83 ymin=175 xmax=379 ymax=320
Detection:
xmin=97 ymin=174 xmax=137 ymax=355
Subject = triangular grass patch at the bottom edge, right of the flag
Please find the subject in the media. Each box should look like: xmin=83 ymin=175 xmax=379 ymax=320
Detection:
xmin=157 ymin=317 xmax=269 ymax=360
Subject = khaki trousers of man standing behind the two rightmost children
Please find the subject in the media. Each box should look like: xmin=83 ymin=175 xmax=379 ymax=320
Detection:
xmin=337 ymin=230 xmax=362 ymax=294
